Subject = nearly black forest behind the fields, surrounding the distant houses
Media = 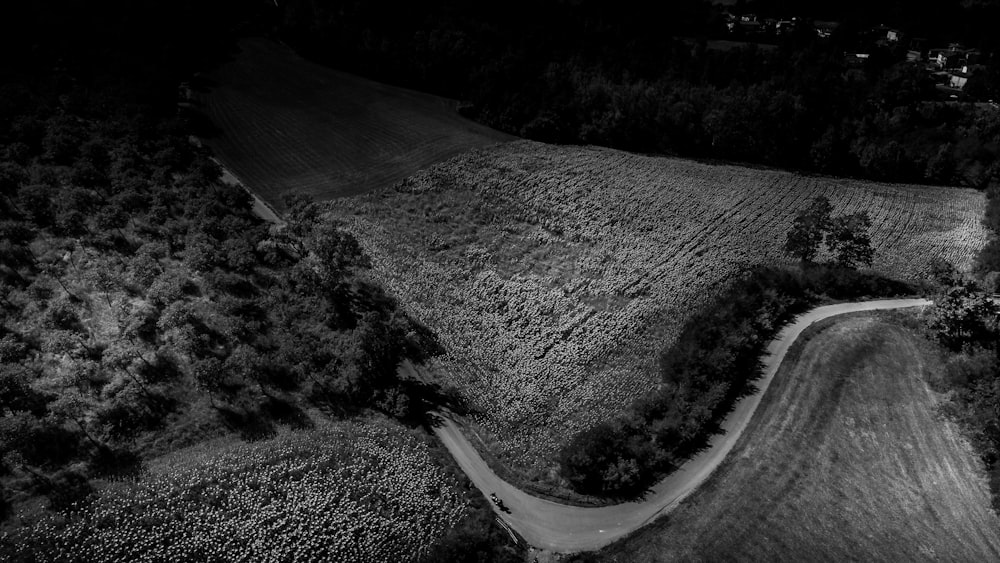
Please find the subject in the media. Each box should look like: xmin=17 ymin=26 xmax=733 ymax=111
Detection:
xmin=274 ymin=0 xmax=1000 ymax=187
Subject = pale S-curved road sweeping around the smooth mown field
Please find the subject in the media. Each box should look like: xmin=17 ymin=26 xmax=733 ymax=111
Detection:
xmin=434 ymin=299 xmax=931 ymax=553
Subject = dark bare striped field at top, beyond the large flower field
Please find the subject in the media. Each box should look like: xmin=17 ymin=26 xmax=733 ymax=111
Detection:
xmin=195 ymin=39 xmax=512 ymax=211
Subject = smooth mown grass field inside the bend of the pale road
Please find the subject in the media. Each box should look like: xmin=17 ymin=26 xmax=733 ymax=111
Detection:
xmin=595 ymin=315 xmax=1000 ymax=562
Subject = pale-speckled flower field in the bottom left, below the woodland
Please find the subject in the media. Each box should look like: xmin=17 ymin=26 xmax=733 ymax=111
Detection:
xmin=8 ymin=421 xmax=466 ymax=562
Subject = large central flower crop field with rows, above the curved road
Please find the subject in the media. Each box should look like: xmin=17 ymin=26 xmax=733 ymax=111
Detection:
xmin=328 ymin=141 xmax=987 ymax=484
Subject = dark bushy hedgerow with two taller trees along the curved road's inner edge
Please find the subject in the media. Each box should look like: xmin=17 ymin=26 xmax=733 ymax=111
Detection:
xmin=559 ymin=206 xmax=892 ymax=497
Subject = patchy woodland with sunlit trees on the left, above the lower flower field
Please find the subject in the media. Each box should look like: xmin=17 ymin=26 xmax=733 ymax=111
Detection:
xmin=0 ymin=34 xmax=420 ymax=524
